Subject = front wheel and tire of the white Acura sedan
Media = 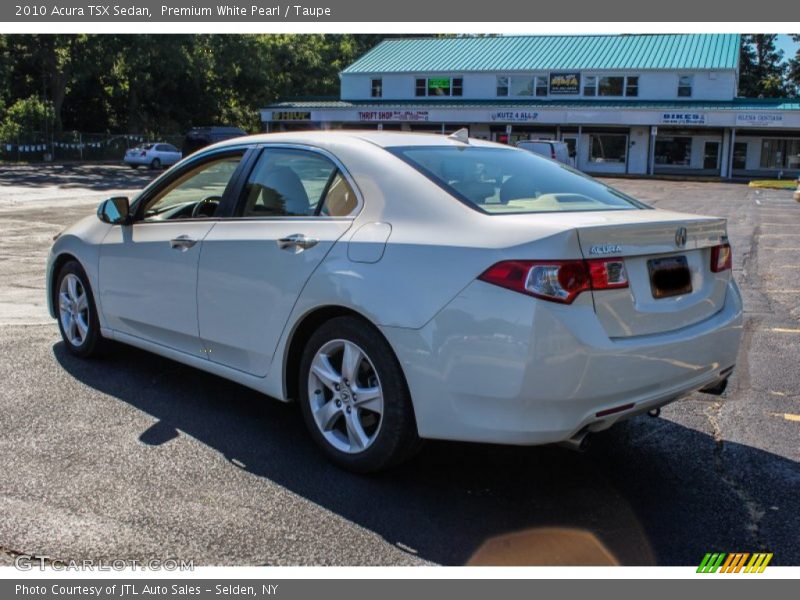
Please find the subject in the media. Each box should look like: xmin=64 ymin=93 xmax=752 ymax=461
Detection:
xmin=53 ymin=260 xmax=105 ymax=358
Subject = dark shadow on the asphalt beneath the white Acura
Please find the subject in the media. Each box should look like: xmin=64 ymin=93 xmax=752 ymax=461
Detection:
xmin=53 ymin=342 xmax=800 ymax=565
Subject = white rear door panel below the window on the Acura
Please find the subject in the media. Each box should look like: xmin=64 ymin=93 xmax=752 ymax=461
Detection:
xmin=197 ymin=218 xmax=352 ymax=377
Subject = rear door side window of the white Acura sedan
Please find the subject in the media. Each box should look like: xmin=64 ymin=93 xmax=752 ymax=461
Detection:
xmin=236 ymin=148 xmax=355 ymax=217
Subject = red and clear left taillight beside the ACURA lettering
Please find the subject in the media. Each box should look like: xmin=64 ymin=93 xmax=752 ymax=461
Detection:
xmin=478 ymin=258 xmax=628 ymax=304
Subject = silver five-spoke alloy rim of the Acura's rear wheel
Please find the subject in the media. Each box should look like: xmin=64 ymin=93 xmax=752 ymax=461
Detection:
xmin=308 ymin=339 xmax=384 ymax=454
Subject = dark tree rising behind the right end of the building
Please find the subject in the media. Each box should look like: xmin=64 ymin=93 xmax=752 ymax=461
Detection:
xmin=739 ymin=33 xmax=788 ymax=98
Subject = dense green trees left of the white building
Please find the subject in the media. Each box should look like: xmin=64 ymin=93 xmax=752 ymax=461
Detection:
xmin=0 ymin=34 xmax=400 ymax=134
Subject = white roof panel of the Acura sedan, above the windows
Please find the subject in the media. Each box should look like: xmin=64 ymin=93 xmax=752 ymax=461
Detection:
xmin=208 ymin=129 xmax=506 ymax=148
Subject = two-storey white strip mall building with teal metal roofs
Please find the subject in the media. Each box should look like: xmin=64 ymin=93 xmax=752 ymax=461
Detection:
xmin=261 ymin=34 xmax=800 ymax=178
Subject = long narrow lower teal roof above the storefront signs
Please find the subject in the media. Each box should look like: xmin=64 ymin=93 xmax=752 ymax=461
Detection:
xmin=266 ymin=98 xmax=800 ymax=111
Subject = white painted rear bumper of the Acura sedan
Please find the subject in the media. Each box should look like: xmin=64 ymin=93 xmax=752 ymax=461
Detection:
xmin=382 ymin=281 xmax=742 ymax=444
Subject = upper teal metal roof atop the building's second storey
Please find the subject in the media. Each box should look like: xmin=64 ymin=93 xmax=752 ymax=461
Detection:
xmin=342 ymin=34 xmax=740 ymax=74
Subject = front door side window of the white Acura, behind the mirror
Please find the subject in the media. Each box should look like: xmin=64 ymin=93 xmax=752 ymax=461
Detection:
xmin=143 ymin=154 xmax=242 ymax=222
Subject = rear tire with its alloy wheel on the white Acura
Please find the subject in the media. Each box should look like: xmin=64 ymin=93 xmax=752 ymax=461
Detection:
xmin=298 ymin=316 xmax=422 ymax=473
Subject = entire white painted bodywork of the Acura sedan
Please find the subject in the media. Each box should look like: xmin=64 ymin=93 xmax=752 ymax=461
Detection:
xmin=48 ymin=132 xmax=742 ymax=444
